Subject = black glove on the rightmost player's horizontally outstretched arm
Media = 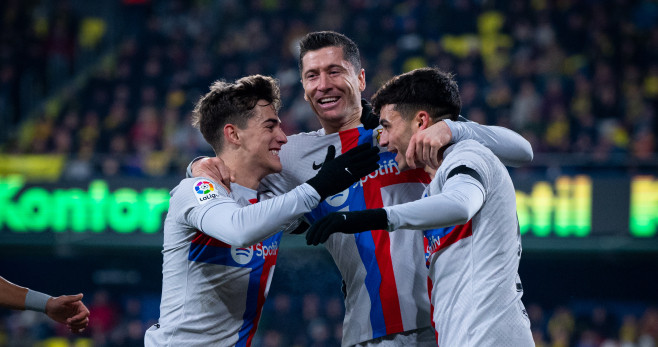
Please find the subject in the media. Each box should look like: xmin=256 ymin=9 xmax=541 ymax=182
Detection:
xmin=306 ymin=208 xmax=388 ymax=245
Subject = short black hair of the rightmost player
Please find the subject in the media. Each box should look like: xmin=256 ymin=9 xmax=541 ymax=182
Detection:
xmin=371 ymin=67 xmax=462 ymax=121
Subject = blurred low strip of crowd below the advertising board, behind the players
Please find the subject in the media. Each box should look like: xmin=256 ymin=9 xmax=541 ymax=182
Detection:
xmin=0 ymin=291 xmax=658 ymax=347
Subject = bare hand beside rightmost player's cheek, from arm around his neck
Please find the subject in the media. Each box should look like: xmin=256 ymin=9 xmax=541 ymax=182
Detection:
xmin=406 ymin=122 xmax=452 ymax=169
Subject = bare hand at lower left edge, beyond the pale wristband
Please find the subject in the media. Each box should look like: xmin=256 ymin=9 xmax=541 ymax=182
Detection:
xmin=46 ymin=294 xmax=89 ymax=333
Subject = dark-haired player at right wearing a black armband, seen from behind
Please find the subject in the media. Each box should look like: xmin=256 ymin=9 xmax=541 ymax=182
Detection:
xmin=306 ymin=68 xmax=534 ymax=347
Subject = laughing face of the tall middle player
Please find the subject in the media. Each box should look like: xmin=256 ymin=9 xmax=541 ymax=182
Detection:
xmin=302 ymin=47 xmax=366 ymax=132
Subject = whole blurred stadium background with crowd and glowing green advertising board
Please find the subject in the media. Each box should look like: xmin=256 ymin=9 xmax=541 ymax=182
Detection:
xmin=0 ymin=0 xmax=658 ymax=346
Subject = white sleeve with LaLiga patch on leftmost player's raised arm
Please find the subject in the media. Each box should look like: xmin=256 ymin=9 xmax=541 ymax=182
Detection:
xmin=174 ymin=179 xmax=320 ymax=247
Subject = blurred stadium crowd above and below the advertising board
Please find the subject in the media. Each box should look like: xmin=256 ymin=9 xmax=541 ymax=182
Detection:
xmin=0 ymin=0 xmax=658 ymax=347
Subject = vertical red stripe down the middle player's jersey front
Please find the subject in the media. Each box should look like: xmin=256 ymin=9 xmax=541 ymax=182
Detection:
xmin=340 ymin=128 xmax=402 ymax=335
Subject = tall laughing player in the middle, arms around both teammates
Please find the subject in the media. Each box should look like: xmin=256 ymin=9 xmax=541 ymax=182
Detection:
xmin=190 ymin=31 xmax=532 ymax=346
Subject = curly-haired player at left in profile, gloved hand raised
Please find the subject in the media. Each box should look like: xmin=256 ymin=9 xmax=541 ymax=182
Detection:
xmin=144 ymin=75 xmax=379 ymax=346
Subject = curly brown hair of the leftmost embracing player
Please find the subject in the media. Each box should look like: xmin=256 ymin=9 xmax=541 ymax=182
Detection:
xmin=192 ymin=75 xmax=281 ymax=154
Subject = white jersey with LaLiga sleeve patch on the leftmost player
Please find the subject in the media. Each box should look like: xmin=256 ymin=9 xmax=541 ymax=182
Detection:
xmin=144 ymin=178 xmax=319 ymax=346
